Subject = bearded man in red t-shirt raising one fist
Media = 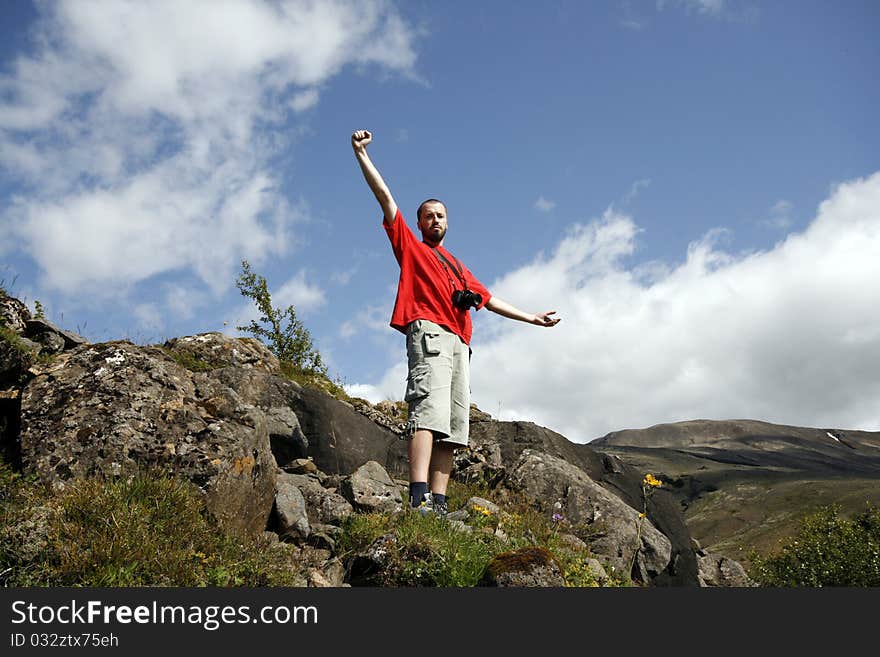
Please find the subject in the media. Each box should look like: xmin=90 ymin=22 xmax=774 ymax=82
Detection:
xmin=351 ymin=130 xmax=559 ymax=515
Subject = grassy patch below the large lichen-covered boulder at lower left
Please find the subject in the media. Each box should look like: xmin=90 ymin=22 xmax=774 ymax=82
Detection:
xmin=0 ymin=458 xmax=305 ymax=587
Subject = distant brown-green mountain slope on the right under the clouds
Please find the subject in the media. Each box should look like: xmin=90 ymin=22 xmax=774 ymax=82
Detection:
xmin=589 ymin=420 xmax=880 ymax=565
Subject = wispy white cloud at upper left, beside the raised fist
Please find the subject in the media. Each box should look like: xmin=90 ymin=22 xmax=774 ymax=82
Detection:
xmin=0 ymin=0 xmax=415 ymax=292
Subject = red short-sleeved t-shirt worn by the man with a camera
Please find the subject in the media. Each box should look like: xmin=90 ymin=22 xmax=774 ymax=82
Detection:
xmin=382 ymin=208 xmax=492 ymax=344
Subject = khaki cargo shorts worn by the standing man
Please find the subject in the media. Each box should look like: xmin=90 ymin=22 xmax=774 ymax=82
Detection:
xmin=403 ymin=319 xmax=471 ymax=446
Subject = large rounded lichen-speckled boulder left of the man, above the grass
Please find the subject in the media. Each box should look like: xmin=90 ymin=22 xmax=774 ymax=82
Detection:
xmin=20 ymin=342 xmax=277 ymax=533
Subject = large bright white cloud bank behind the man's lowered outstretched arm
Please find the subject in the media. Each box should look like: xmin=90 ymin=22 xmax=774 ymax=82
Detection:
xmin=354 ymin=172 xmax=880 ymax=442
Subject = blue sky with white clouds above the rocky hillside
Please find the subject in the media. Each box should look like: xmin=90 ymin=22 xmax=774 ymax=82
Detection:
xmin=0 ymin=0 xmax=880 ymax=442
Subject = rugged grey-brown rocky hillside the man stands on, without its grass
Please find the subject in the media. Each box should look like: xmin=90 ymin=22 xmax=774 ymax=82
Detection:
xmin=0 ymin=290 xmax=748 ymax=586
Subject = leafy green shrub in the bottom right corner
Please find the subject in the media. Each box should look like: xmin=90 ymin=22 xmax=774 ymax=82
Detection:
xmin=750 ymin=504 xmax=880 ymax=587
